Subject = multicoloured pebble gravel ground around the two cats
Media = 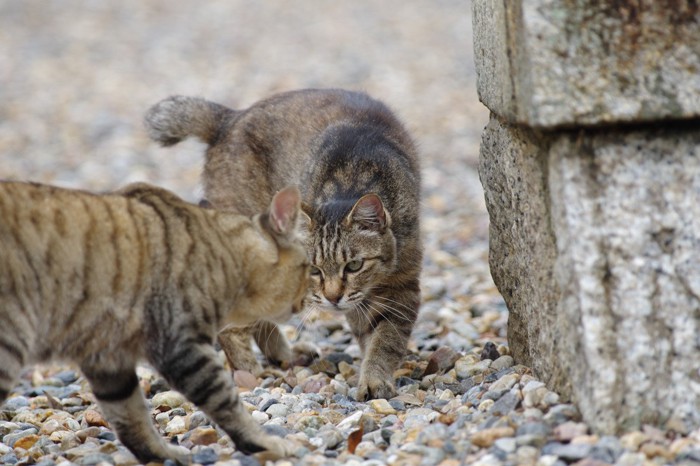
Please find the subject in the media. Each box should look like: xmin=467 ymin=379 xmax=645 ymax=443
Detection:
xmin=0 ymin=0 xmax=700 ymax=466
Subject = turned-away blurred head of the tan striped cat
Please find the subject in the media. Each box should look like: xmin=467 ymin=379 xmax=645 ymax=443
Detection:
xmin=221 ymin=187 xmax=310 ymax=325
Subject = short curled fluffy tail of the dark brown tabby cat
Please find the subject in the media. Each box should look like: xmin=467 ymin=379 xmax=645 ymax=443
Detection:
xmin=144 ymin=95 xmax=236 ymax=146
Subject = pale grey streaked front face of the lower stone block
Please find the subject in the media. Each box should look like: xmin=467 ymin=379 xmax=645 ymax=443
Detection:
xmin=549 ymin=124 xmax=700 ymax=431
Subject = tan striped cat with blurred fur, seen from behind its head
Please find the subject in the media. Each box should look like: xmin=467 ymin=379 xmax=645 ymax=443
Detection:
xmin=0 ymin=182 xmax=309 ymax=463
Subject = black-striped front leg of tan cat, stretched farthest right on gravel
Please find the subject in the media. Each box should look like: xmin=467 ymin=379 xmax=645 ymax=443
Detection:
xmin=153 ymin=340 xmax=295 ymax=457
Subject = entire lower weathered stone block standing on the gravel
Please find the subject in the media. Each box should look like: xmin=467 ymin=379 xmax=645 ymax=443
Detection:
xmin=480 ymin=118 xmax=700 ymax=433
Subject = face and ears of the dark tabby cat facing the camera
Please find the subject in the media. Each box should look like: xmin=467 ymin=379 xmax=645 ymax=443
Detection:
xmin=302 ymin=193 xmax=396 ymax=311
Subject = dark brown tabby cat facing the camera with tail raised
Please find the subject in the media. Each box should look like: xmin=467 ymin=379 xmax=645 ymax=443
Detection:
xmin=145 ymin=89 xmax=422 ymax=399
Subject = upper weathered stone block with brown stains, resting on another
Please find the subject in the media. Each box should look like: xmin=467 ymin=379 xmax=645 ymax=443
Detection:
xmin=473 ymin=0 xmax=700 ymax=128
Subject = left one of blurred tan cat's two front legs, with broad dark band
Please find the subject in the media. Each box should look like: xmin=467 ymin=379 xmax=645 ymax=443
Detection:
xmin=82 ymin=367 xmax=189 ymax=464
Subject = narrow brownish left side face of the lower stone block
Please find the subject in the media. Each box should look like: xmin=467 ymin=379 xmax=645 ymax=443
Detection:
xmin=479 ymin=116 xmax=570 ymax=393
